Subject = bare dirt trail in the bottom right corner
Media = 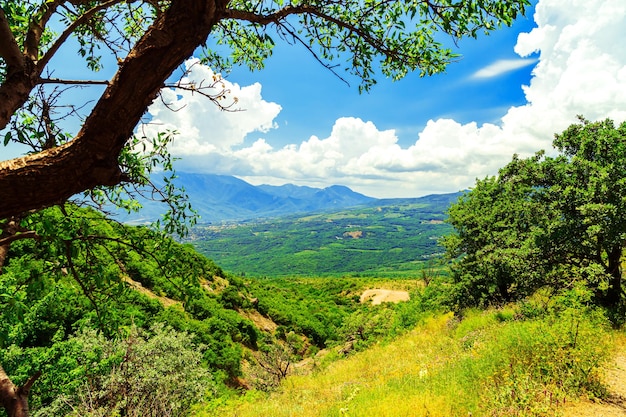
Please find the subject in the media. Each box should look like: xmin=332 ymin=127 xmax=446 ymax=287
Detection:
xmin=563 ymin=346 xmax=626 ymax=417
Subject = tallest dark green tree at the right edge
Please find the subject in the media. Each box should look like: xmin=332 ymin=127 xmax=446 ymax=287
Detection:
xmin=538 ymin=117 xmax=626 ymax=307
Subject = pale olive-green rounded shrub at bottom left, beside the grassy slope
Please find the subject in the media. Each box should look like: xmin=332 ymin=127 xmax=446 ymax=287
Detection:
xmin=35 ymin=325 xmax=214 ymax=417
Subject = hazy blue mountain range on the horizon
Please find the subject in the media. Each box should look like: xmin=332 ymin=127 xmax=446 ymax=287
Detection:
xmin=120 ymin=172 xmax=376 ymax=223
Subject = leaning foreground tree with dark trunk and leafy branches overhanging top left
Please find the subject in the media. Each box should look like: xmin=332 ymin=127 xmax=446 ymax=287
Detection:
xmin=0 ymin=0 xmax=530 ymax=416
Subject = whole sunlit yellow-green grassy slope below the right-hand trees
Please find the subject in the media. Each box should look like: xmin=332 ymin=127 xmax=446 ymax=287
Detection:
xmin=196 ymin=306 xmax=612 ymax=417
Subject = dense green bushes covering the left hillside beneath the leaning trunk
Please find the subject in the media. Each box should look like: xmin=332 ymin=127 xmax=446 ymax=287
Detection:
xmin=0 ymin=204 xmax=259 ymax=408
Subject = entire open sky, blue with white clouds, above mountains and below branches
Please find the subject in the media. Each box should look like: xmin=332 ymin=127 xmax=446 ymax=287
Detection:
xmin=3 ymin=0 xmax=626 ymax=198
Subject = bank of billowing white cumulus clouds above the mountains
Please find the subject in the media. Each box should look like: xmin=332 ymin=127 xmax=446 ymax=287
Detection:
xmin=144 ymin=0 xmax=626 ymax=197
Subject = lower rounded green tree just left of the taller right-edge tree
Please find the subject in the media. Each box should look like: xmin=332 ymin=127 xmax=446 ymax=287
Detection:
xmin=442 ymin=163 xmax=545 ymax=307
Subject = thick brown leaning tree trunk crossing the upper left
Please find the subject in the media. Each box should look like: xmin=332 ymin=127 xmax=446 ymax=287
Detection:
xmin=0 ymin=0 xmax=228 ymax=219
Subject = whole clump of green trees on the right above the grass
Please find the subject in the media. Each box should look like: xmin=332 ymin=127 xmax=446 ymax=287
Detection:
xmin=443 ymin=117 xmax=626 ymax=308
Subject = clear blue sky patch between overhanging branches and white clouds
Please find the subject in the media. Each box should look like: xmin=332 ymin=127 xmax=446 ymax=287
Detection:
xmin=223 ymin=10 xmax=536 ymax=148
